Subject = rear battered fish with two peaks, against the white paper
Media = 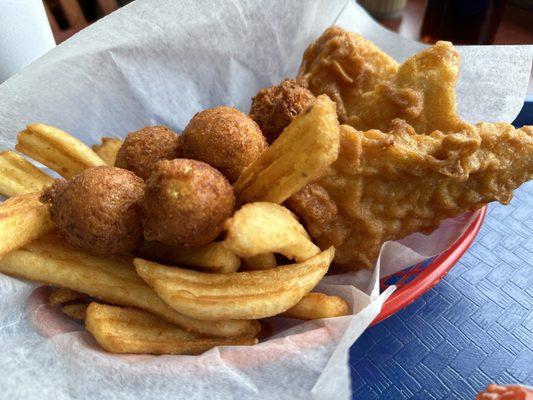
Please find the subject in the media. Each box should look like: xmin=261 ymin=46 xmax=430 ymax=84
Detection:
xmin=298 ymin=27 xmax=466 ymax=133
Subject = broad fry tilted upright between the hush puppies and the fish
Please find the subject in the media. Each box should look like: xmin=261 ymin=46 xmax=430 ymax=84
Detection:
xmin=234 ymin=96 xmax=339 ymax=203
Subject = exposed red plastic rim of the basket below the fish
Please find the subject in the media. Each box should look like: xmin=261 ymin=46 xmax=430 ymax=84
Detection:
xmin=372 ymin=206 xmax=487 ymax=325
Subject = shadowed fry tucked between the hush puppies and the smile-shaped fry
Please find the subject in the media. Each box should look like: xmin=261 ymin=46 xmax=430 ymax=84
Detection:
xmin=139 ymin=242 xmax=241 ymax=273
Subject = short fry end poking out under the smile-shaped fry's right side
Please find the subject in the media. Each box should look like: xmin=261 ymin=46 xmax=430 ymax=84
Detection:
xmin=280 ymin=292 xmax=350 ymax=319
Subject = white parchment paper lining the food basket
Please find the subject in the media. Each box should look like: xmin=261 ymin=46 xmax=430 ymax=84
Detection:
xmin=0 ymin=0 xmax=533 ymax=400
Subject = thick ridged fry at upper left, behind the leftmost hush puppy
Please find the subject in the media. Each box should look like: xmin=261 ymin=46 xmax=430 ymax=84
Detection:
xmin=15 ymin=124 xmax=106 ymax=179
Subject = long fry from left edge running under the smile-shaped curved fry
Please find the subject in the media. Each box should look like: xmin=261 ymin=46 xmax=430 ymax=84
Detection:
xmin=0 ymin=235 xmax=260 ymax=337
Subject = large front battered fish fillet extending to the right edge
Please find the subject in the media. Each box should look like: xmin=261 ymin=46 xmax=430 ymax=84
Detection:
xmin=286 ymin=120 xmax=533 ymax=269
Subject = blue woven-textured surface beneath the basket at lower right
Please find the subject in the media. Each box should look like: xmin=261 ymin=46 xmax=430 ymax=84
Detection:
xmin=350 ymin=101 xmax=533 ymax=400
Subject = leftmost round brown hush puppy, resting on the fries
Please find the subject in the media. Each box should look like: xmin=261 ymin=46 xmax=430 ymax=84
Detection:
xmin=41 ymin=166 xmax=144 ymax=254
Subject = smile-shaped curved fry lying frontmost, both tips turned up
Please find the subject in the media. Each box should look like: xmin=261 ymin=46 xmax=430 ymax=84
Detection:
xmin=133 ymin=247 xmax=335 ymax=320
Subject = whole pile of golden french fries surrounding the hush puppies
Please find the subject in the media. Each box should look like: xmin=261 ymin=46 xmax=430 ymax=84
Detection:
xmin=0 ymin=96 xmax=349 ymax=354
